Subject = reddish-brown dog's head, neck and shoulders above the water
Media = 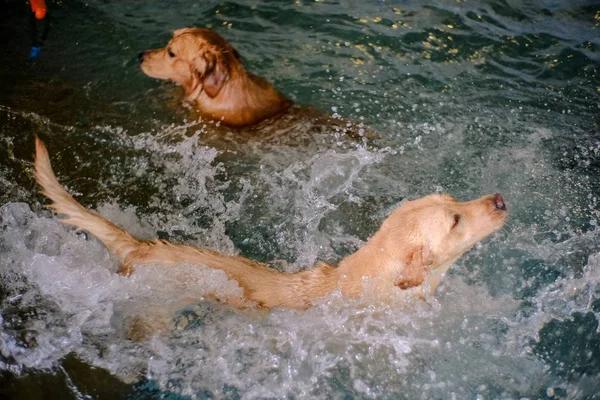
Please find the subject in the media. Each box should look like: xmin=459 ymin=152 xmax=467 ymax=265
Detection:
xmin=138 ymin=28 xmax=292 ymax=127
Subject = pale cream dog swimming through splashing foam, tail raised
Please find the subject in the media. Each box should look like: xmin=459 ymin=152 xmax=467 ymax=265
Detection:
xmin=35 ymin=139 xmax=508 ymax=309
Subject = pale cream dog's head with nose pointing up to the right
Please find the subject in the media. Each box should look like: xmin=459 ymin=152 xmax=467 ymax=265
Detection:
xmin=360 ymin=194 xmax=508 ymax=289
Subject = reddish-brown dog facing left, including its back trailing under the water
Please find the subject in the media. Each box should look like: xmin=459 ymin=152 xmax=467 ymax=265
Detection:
xmin=138 ymin=28 xmax=378 ymax=139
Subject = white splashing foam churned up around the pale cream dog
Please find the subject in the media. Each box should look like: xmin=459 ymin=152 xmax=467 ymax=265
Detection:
xmin=0 ymin=115 xmax=600 ymax=398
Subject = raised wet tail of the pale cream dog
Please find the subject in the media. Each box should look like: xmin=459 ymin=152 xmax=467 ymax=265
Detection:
xmin=35 ymin=137 xmax=143 ymax=261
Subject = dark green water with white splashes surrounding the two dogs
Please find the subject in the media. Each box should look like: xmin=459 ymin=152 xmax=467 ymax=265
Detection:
xmin=0 ymin=0 xmax=600 ymax=399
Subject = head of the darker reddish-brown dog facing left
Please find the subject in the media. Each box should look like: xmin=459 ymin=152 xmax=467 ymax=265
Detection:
xmin=138 ymin=28 xmax=241 ymax=101
